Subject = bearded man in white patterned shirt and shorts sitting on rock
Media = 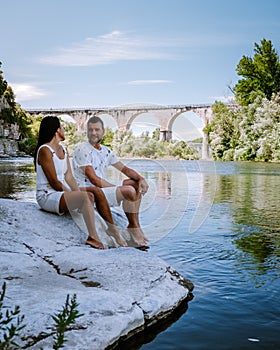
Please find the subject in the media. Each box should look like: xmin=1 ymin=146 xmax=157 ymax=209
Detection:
xmin=73 ymin=117 xmax=149 ymax=246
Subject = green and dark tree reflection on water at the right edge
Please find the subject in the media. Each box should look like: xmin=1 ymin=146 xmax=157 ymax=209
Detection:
xmin=211 ymin=163 xmax=280 ymax=276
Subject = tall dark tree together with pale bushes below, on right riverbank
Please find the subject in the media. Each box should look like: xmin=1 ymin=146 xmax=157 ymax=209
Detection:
xmin=204 ymin=39 xmax=280 ymax=161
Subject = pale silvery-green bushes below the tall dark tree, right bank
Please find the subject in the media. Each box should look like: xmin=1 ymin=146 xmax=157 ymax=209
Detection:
xmin=205 ymin=93 xmax=280 ymax=161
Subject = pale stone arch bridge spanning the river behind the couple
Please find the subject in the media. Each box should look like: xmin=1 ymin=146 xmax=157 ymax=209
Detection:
xmin=26 ymin=105 xmax=212 ymax=159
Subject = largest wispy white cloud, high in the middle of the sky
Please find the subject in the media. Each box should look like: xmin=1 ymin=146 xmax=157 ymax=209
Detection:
xmin=39 ymin=31 xmax=182 ymax=66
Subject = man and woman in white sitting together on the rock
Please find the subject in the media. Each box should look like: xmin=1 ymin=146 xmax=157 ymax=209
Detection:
xmin=34 ymin=116 xmax=149 ymax=249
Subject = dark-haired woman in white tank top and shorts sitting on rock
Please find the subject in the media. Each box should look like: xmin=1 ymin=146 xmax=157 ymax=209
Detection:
xmin=34 ymin=116 xmax=126 ymax=249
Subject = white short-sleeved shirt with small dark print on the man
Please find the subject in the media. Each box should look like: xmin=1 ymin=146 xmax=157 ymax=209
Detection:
xmin=72 ymin=142 xmax=119 ymax=187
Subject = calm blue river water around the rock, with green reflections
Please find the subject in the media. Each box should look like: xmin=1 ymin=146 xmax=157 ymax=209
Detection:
xmin=0 ymin=159 xmax=280 ymax=350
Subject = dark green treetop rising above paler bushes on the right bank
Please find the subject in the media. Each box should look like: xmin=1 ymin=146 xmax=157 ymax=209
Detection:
xmin=233 ymin=39 xmax=280 ymax=106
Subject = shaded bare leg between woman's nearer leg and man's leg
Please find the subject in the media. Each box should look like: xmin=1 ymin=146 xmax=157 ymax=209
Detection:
xmin=80 ymin=187 xmax=127 ymax=247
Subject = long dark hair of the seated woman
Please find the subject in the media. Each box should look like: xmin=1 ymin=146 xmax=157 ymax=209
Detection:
xmin=34 ymin=116 xmax=60 ymax=169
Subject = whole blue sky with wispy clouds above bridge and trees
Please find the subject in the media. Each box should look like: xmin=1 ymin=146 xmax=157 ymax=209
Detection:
xmin=0 ymin=0 xmax=280 ymax=139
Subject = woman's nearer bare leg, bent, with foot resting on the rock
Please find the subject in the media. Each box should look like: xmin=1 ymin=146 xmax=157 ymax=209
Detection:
xmin=59 ymin=191 xmax=104 ymax=249
